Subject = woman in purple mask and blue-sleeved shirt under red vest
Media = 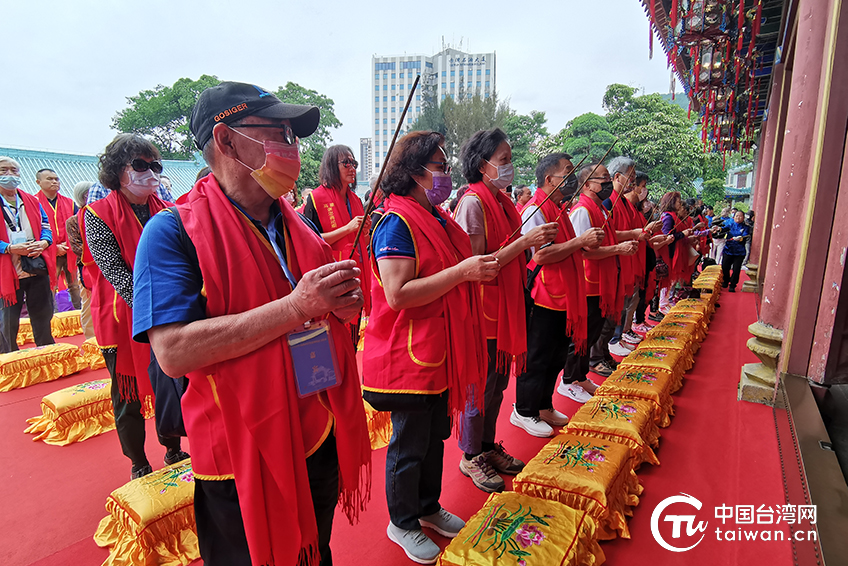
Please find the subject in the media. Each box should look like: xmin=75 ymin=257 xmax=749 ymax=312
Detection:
xmin=362 ymin=132 xmax=500 ymax=564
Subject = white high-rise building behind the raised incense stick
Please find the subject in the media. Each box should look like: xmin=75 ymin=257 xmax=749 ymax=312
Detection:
xmin=372 ymin=47 xmax=496 ymax=177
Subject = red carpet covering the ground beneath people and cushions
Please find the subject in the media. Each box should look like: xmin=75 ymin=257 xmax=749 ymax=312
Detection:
xmin=0 ymin=293 xmax=791 ymax=566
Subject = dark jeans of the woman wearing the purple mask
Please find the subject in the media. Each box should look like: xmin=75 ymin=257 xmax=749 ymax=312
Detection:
xmin=364 ymin=391 xmax=450 ymax=531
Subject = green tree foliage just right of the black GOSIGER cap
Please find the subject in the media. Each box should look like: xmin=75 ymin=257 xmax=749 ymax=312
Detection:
xmin=274 ymin=81 xmax=342 ymax=192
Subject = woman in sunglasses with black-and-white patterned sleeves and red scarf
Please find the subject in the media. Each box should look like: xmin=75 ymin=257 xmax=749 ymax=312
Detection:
xmin=80 ymin=134 xmax=188 ymax=479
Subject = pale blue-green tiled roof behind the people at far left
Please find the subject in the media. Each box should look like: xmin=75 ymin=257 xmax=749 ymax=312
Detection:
xmin=0 ymin=147 xmax=206 ymax=198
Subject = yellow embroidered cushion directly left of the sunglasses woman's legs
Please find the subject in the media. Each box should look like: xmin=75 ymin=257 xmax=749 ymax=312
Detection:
xmin=24 ymin=379 xmax=115 ymax=446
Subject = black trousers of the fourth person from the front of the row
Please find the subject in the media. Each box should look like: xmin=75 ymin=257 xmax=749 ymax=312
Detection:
xmin=515 ymin=305 xmax=571 ymax=417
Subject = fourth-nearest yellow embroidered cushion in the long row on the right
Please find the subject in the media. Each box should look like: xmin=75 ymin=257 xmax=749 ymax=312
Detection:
xmin=595 ymin=368 xmax=679 ymax=427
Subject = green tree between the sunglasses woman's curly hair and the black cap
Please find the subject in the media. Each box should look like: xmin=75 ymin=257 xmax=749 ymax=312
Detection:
xmin=112 ymin=75 xmax=221 ymax=159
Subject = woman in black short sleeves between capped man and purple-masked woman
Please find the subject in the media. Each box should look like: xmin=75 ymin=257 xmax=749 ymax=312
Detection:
xmin=303 ymin=145 xmax=371 ymax=342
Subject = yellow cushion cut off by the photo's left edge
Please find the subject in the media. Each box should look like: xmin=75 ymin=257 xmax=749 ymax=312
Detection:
xmin=0 ymin=344 xmax=88 ymax=391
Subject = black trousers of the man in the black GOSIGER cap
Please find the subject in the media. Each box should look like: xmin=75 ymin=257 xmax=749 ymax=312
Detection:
xmin=194 ymin=434 xmax=339 ymax=566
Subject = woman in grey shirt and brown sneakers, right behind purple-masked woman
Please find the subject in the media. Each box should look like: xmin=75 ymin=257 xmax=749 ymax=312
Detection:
xmin=454 ymin=128 xmax=557 ymax=492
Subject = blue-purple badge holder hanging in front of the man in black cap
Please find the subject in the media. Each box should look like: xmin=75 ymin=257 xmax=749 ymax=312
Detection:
xmin=286 ymin=320 xmax=342 ymax=397
